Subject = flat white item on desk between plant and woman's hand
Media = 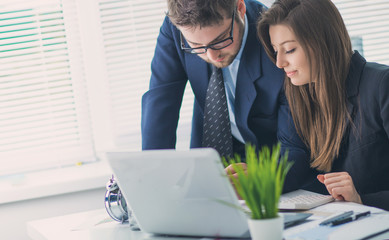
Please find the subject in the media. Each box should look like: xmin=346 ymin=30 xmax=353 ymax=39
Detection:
xmin=278 ymin=189 xmax=334 ymax=210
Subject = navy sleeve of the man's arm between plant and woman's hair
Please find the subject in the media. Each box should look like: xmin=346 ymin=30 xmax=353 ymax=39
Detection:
xmin=277 ymin=91 xmax=328 ymax=194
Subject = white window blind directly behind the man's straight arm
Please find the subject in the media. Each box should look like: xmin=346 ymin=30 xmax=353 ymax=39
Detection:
xmin=99 ymin=0 xmax=193 ymax=150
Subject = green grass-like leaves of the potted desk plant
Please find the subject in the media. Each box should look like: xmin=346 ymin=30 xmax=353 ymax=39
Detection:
xmin=223 ymin=143 xmax=292 ymax=219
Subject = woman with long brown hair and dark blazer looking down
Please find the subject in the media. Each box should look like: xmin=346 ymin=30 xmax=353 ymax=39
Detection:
xmin=258 ymin=0 xmax=389 ymax=210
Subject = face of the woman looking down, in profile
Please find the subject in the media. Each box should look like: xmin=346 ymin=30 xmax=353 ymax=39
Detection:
xmin=269 ymin=24 xmax=313 ymax=86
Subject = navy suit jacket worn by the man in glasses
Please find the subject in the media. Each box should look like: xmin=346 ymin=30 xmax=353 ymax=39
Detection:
xmin=142 ymin=1 xmax=283 ymax=149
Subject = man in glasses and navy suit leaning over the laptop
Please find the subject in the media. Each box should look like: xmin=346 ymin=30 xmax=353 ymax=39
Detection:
xmin=142 ymin=0 xmax=286 ymax=156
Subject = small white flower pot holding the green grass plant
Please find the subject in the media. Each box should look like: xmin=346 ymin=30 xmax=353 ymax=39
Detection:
xmin=248 ymin=216 xmax=284 ymax=240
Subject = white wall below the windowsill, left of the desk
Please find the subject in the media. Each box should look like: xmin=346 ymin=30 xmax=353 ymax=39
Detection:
xmin=0 ymin=187 xmax=105 ymax=240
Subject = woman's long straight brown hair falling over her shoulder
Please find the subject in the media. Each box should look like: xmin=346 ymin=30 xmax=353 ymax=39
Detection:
xmin=258 ymin=0 xmax=353 ymax=171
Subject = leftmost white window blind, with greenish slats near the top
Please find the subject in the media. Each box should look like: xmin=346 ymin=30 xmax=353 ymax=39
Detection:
xmin=0 ymin=0 xmax=95 ymax=175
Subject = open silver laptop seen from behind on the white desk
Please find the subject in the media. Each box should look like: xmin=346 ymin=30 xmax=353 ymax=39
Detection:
xmin=106 ymin=148 xmax=312 ymax=238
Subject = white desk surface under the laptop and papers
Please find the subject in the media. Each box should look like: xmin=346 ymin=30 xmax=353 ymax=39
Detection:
xmin=27 ymin=202 xmax=389 ymax=240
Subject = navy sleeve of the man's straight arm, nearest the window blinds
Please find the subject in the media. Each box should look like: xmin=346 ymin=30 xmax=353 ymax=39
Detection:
xmin=141 ymin=17 xmax=187 ymax=149
